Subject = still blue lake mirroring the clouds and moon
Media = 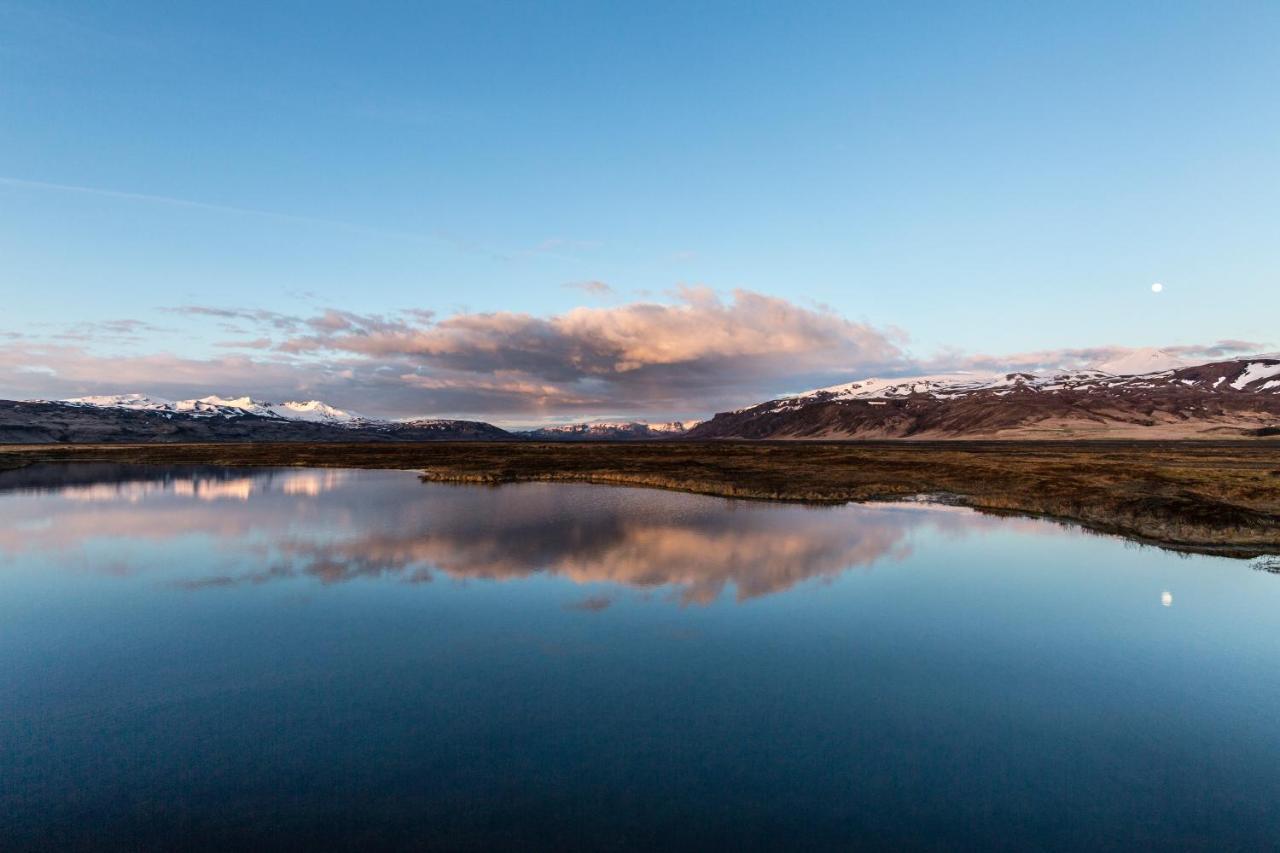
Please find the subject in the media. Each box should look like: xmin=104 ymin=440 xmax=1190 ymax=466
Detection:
xmin=0 ymin=466 xmax=1280 ymax=849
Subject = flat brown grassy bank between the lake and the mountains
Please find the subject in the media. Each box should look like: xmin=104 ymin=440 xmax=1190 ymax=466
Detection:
xmin=0 ymin=441 xmax=1280 ymax=555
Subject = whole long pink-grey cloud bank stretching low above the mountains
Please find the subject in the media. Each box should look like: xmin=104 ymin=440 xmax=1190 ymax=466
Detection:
xmin=0 ymin=288 xmax=1263 ymax=423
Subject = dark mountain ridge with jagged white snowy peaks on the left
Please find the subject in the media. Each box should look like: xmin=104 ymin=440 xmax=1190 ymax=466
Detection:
xmin=0 ymin=394 xmax=513 ymax=444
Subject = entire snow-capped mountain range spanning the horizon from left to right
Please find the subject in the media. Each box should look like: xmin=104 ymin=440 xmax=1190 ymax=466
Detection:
xmin=0 ymin=351 xmax=1280 ymax=444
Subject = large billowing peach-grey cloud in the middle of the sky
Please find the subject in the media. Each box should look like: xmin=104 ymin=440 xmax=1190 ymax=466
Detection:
xmin=282 ymin=288 xmax=905 ymax=394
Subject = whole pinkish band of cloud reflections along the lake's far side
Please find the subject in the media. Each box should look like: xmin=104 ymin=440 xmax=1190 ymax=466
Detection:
xmin=0 ymin=469 xmax=1053 ymax=601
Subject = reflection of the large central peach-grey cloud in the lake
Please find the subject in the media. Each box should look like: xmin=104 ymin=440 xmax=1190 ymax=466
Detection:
xmin=246 ymin=507 xmax=918 ymax=603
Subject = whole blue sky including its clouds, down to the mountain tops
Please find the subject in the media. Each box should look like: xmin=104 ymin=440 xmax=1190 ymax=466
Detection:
xmin=0 ymin=0 xmax=1280 ymax=425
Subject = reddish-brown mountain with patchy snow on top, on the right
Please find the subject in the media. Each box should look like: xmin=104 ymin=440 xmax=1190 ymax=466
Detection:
xmin=686 ymin=356 xmax=1280 ymax=439
